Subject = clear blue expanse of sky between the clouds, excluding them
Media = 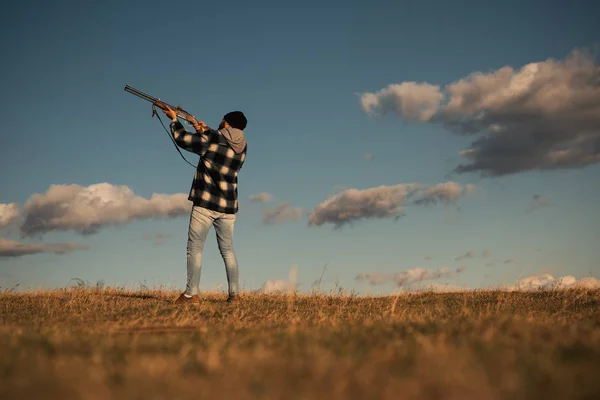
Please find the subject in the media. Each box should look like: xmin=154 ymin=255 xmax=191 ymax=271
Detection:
xmin=0 ymin=1 xmax=600 ymax=293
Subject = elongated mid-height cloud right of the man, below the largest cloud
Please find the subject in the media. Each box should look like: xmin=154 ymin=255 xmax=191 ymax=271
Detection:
xmin=309 ymin=182 xmax=472 ymax=228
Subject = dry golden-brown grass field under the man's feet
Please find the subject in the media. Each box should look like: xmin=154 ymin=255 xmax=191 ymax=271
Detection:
xmin=0 ymin=288 xmax=600 ymax=400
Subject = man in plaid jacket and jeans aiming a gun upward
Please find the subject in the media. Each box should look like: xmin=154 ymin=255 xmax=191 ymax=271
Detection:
xmin=156 ymin=102 xmax=247 ymax=303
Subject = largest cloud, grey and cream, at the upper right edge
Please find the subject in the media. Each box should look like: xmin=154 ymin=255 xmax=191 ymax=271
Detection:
xmin=360 ymin=50 xmax=600 ymax=176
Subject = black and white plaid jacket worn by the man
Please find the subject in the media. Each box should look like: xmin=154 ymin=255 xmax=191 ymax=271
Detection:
xmin=171 ymin=121 xmax=248 ymax=214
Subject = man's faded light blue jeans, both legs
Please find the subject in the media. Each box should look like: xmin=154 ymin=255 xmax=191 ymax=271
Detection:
xmin=185 ymin=206 xmax=239 ymax=296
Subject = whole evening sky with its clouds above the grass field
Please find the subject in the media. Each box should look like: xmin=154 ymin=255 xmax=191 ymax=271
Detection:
xmin=0 ymin=0 xmax=600 ymax=294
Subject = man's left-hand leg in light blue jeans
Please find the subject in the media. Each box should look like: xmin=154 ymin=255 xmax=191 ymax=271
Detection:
xmin=185 ymin=206 xmax=213 ymax=296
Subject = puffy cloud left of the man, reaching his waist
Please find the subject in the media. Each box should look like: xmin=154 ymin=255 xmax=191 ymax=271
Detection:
xmin=21 ymin=183 xmax=191 ymax=237
